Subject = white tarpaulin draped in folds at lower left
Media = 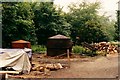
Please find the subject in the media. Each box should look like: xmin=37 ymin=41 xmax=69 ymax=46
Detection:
xmin=0 ymin=49 xmax=31 ymax=73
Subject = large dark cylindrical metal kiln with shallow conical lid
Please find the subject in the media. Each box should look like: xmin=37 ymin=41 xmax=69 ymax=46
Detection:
xmin=47 ymin=35 xmax=72 ymax=56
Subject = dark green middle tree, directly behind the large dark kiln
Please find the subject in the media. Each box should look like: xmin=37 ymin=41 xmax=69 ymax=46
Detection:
xmin=32 ymin=2 xmax=70 ymax=44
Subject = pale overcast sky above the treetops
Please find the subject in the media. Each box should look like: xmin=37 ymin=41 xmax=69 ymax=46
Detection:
xmin=54 ymin=0 xmax=119 ymax=19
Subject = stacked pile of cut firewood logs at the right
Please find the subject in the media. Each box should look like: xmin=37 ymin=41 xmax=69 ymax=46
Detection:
xmin=93 ymin=42 xmax=118 ymax=54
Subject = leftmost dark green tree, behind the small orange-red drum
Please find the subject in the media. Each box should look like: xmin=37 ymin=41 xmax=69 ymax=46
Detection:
xmin=2 ymin=2 xmax=36 ymax=47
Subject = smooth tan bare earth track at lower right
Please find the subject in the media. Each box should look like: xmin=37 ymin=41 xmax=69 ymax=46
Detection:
xmin=50 ymin=54 xmax=118 ymax=78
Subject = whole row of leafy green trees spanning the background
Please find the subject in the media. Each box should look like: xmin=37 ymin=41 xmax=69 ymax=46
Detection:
xmin=2 ymin=2 xmax=116 ymax=47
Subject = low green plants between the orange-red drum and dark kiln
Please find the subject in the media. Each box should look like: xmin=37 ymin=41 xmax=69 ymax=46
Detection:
xmin=32 ymin=45 xmax=47 ymax=53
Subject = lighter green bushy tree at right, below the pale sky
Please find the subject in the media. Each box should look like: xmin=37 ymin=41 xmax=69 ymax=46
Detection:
xmin=66 ymin=2 xmax=114 ymax=43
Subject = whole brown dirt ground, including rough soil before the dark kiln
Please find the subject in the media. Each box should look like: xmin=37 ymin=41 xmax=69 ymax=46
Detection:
xmin=10 ymin=54 xmax=118 ymax=78
